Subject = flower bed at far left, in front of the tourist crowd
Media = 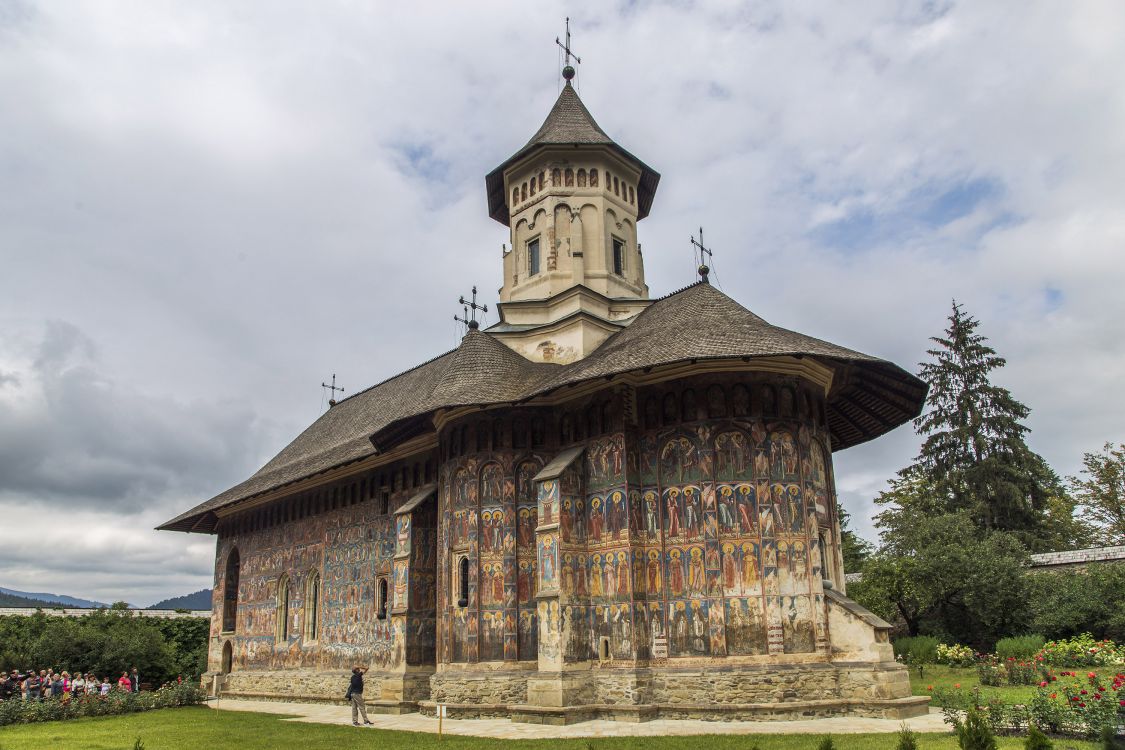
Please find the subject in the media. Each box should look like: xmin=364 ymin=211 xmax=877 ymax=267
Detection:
xmin=0 ymin=684 xmax=205 ymax=726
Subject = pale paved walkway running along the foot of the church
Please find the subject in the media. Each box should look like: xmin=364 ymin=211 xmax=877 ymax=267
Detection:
xmin=207 ymin=698 xmax=950 ymax=740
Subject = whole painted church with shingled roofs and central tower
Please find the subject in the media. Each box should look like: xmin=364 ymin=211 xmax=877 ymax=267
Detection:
xmin=160 ymin=60 xmax=927 ymax=723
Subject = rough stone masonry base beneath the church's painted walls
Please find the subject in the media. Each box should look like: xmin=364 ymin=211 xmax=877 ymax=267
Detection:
xmin=214 ymin=662 xmax=929 ymax=724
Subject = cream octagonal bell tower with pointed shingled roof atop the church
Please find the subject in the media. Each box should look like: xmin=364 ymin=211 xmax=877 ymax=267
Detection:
xmin=486 ymin=72 xmax=660 ymax=363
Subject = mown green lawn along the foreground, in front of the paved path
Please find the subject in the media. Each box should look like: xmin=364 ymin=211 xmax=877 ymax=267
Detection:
xmin=0 ymin=706 xmax=1095 ymax=750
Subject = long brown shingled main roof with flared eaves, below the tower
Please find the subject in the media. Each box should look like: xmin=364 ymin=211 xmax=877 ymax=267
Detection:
xmin=160 ymin=282 xmax=926 ymax=531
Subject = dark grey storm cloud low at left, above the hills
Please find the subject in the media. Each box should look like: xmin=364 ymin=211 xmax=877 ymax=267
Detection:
xmin=0 ymin=320 xmax=271 ymax=513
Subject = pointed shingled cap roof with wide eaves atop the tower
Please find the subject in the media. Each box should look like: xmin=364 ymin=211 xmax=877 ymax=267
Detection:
xmin=485 ymin=81 xmax=660 ymax=226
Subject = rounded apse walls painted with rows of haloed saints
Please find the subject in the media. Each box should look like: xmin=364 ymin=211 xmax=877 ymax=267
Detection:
xmin=439 ymin=376 xmax=836 ymax=668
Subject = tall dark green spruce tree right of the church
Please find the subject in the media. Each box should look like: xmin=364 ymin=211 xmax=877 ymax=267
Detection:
xmin=903 ymin=301 xmax=1064 ymax=549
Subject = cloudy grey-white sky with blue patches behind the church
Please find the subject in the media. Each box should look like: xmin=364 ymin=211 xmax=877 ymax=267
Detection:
xmin=0 ymin=0 xmax=1125 ymax=605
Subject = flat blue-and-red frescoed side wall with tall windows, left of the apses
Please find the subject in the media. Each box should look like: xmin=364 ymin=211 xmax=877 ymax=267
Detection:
xmin=209 ymin=454 xmax=435 ymax=671
